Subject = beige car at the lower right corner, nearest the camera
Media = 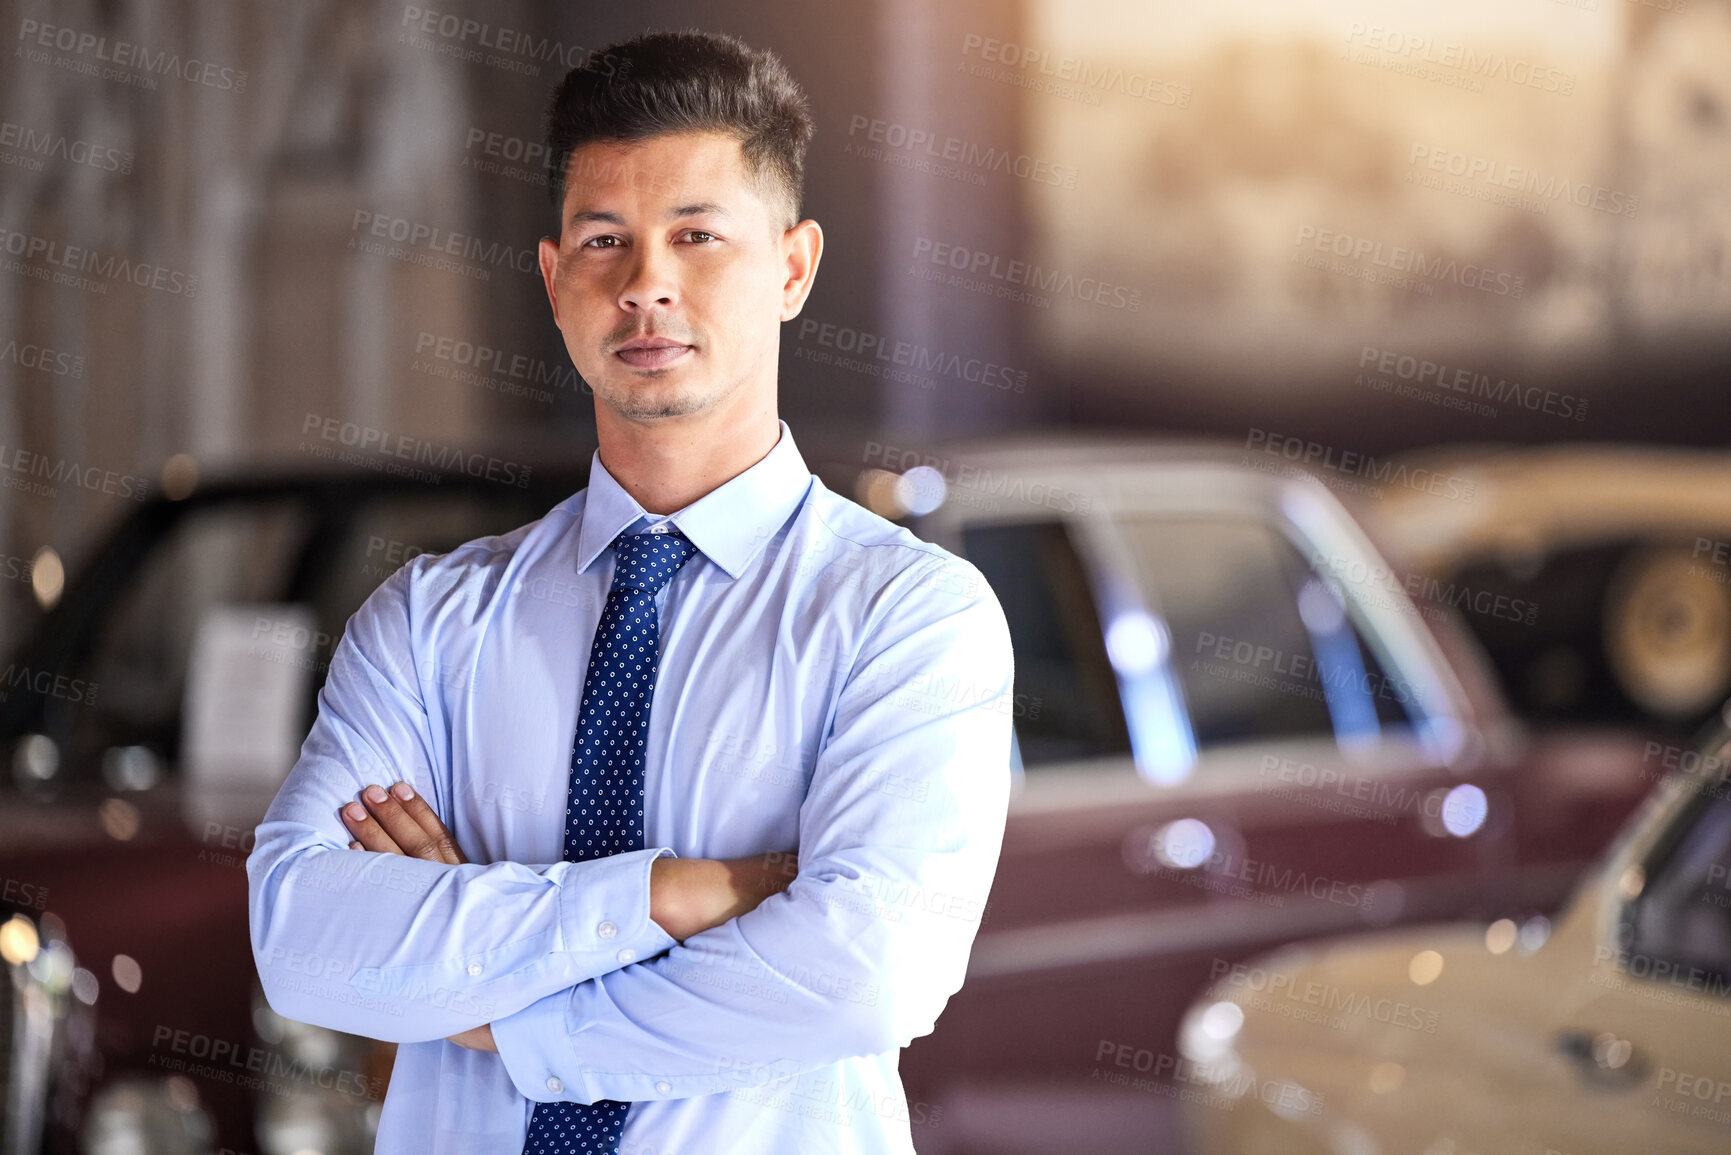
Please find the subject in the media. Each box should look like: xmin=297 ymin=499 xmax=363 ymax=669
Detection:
xmin=1184 ymin=707 xmax=1731 ymax=1155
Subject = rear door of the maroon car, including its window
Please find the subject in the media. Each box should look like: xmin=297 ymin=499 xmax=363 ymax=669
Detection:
xmin=1113 ymin=500 xmax=1513 ymax=945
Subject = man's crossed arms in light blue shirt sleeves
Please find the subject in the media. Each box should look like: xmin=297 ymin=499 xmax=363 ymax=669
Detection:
xmin=248 ymin=558 xmax=1011 ymax=1103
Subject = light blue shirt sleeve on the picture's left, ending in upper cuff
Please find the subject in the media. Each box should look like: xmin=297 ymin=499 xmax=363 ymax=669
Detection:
xmin=246 ymin=563 xmax=673 ymax=1042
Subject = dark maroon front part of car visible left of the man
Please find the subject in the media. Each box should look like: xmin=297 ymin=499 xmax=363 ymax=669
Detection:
xmin=0 ymin=454 xmax=587 ymax=1155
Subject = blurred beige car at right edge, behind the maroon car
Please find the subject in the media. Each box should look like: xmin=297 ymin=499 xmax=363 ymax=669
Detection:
xmin=1362 ymin=445 xmax=1731 ymax=732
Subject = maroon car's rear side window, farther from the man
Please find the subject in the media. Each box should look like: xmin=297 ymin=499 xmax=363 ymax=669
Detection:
xmin=1120 ymin=516 xmax=1412 ymax=746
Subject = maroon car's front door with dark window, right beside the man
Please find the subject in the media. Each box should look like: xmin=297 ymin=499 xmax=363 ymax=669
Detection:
xmin=902 ymin=518 xmax=1208 ymax=1094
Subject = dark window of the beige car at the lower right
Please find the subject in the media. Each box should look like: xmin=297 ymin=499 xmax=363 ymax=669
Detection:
xmin=1631 ymin=779 xmax=1731 ymax=977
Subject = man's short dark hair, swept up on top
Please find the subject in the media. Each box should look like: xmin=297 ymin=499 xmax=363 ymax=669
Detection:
xmin=547 ymin=29 xmax=812 ymax=227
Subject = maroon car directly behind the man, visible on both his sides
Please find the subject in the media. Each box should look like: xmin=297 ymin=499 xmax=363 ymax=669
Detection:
xmin=0 ymin=442 xmax=1657 ymax=1155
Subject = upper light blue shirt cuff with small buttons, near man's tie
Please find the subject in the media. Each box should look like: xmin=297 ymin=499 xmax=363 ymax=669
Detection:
xmin=549 ymin=847 xmax=677 ymax=977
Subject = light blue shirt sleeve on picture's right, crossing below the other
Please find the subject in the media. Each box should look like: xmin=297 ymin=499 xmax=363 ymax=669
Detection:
xmin=493 ymin=558 xmax=1013 ymax=1103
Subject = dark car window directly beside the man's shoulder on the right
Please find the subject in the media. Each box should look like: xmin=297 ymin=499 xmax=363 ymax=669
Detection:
xmin=962 ymin=521 xmax=1130 ymax=771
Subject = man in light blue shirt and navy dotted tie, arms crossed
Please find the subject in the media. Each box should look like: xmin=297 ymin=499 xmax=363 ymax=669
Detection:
xmin=248 ymin=27 xmax=1011 ymax=1155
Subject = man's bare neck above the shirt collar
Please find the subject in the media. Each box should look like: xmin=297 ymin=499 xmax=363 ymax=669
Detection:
xmin=595 ymin=398 xmax=781 ymax=516
